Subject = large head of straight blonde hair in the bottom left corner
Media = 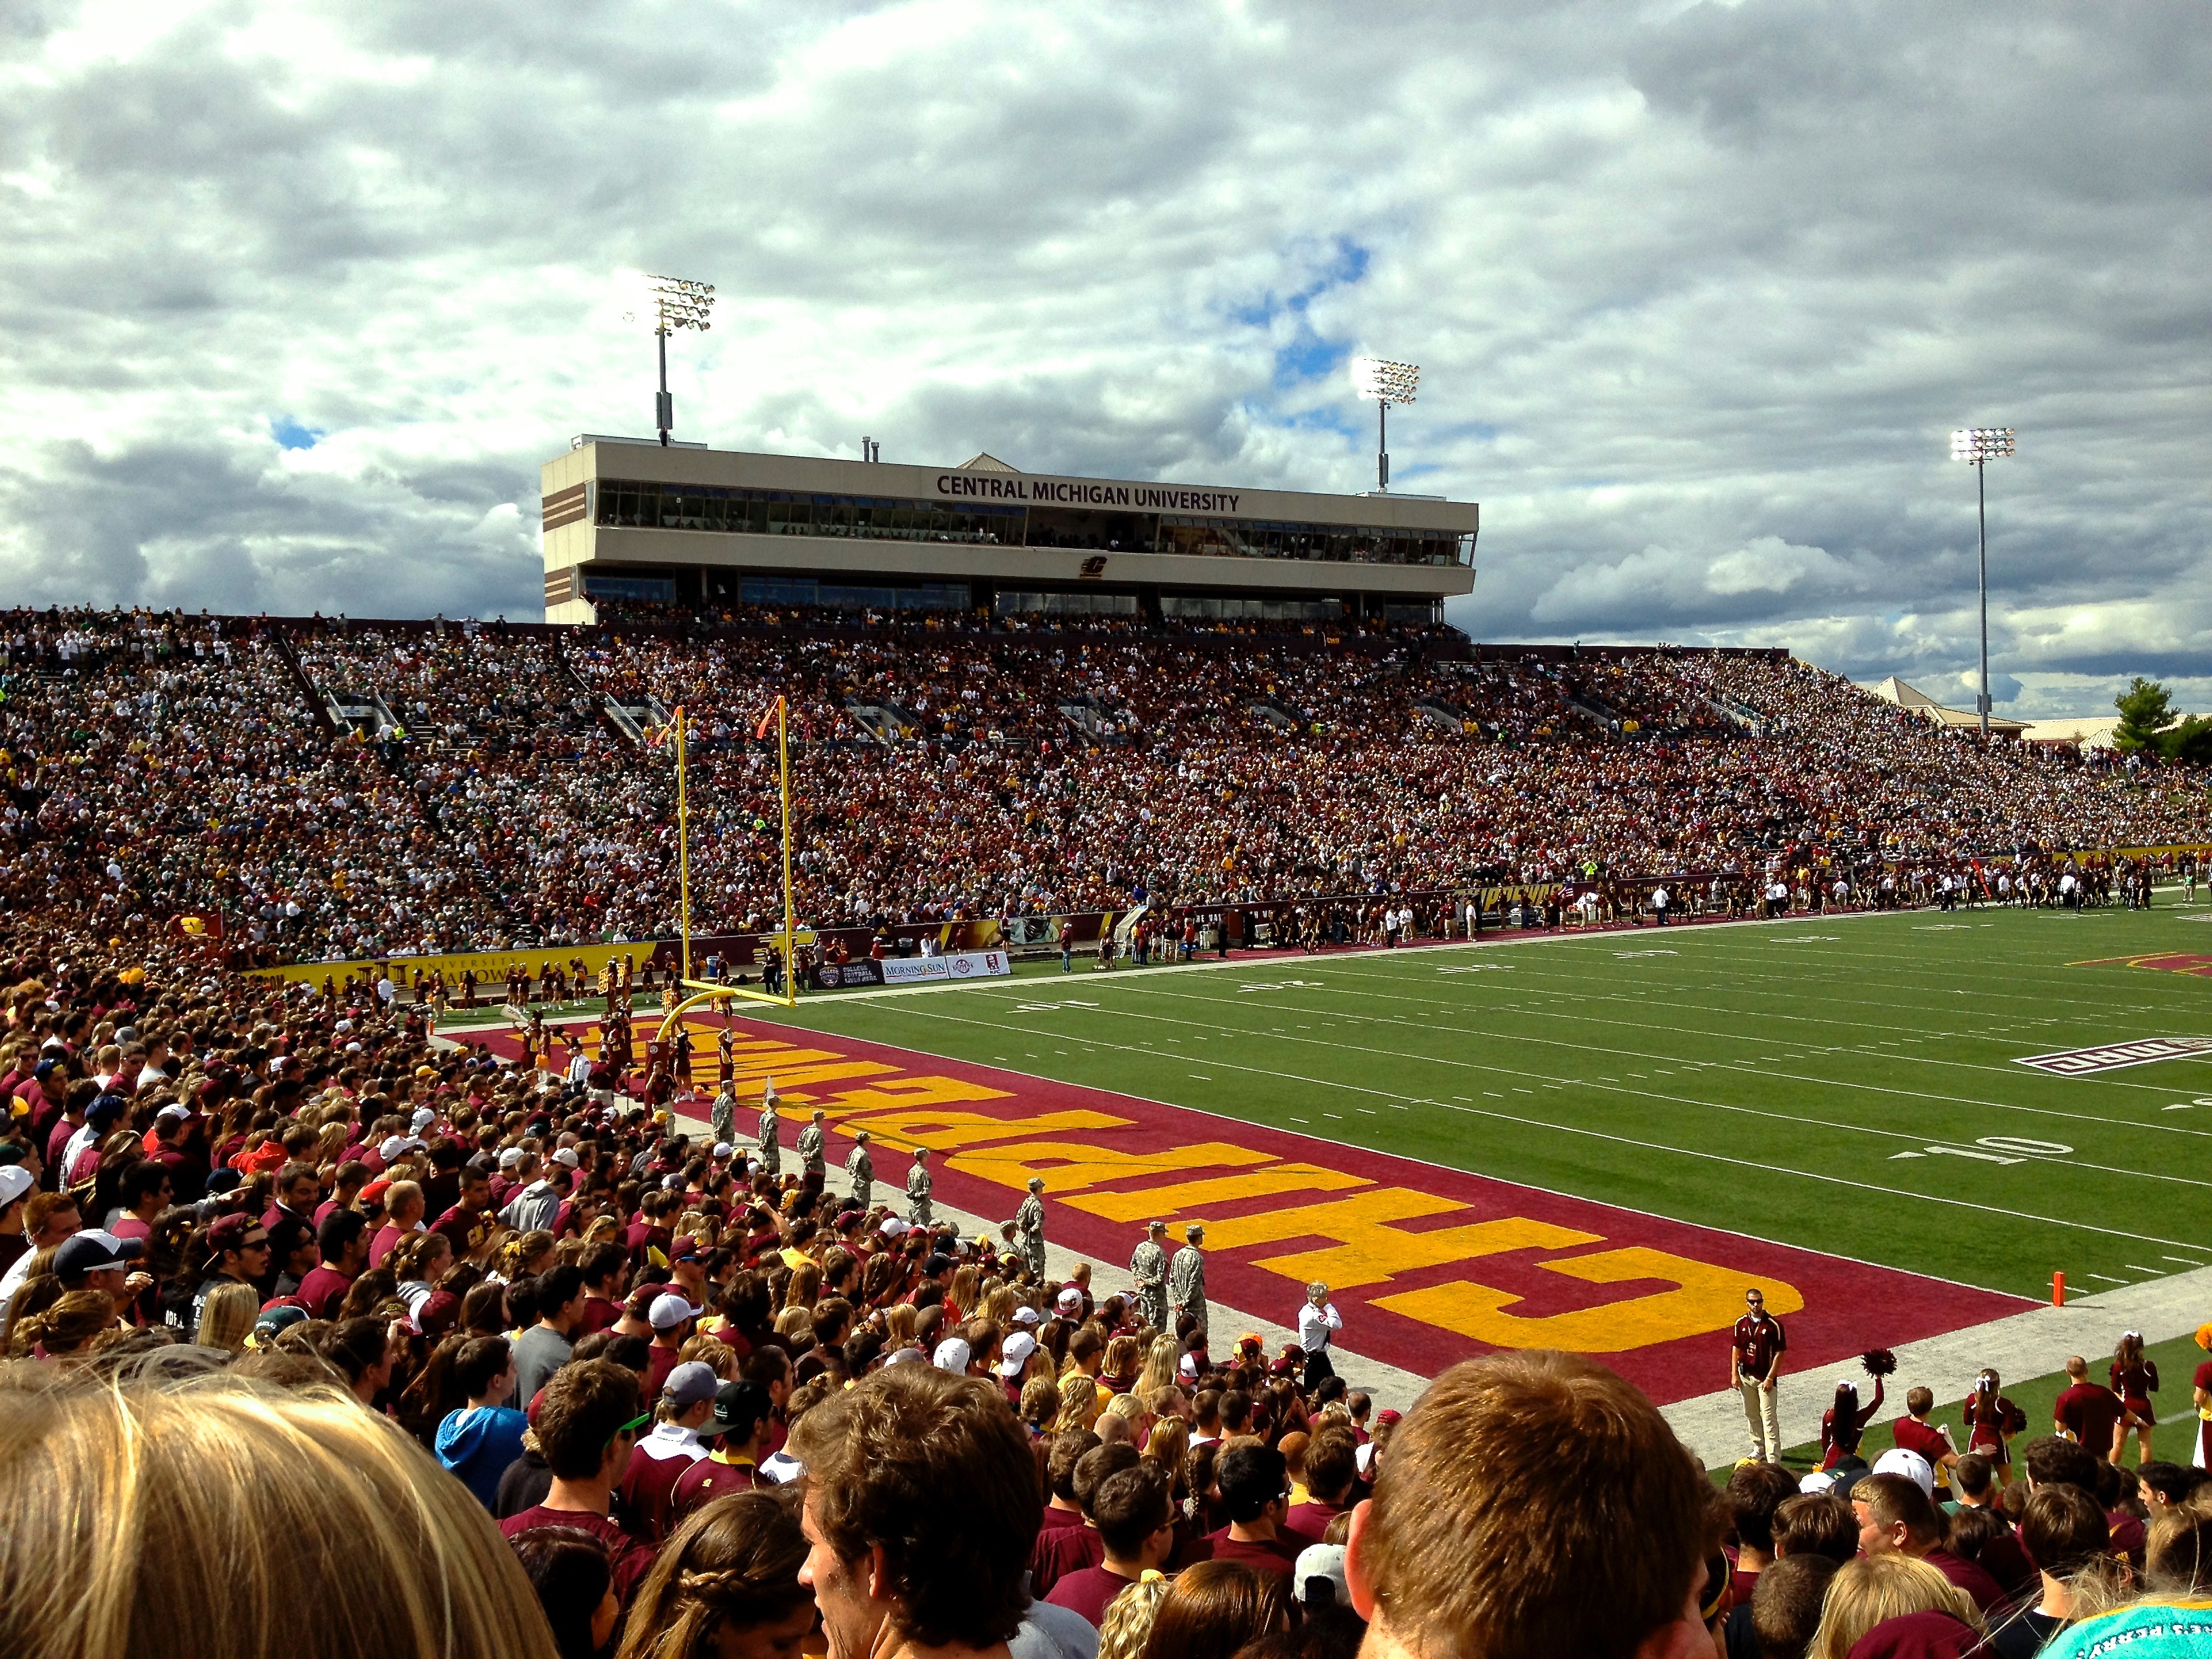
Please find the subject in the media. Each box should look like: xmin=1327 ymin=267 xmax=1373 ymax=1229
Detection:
xmin=0 ymin=1365 xmax=555 ymax=1659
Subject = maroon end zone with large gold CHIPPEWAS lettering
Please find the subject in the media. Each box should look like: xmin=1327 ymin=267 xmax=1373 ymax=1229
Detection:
xmin=487 ymin=1022 xmax=2028 ymax=1405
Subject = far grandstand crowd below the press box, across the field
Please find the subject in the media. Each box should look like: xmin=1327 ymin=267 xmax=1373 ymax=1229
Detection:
xmin=0 ymin=611 xmax=2212 ymax=960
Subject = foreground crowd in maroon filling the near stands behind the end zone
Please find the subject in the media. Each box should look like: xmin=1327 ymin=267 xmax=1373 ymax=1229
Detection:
xmin=0 ymin=912 xmax=2212 ymax=1659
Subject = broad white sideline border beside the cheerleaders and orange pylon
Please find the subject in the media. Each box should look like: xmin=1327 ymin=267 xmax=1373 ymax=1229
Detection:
xmin=1661 ymin=1267 xmax=2212 ymax=1469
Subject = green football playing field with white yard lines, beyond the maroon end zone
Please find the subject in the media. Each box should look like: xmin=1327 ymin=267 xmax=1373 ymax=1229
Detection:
xmin=681 ymin=907 xmax=2212 ymax=1298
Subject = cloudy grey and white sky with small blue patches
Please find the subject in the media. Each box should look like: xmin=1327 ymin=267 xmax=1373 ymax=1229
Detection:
xmin=0 ymin=0 xmax=2212 ymax=712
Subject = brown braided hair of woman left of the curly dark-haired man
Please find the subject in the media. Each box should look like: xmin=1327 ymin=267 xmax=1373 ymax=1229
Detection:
xmin=615 ymin=1486 xmax=812 ymax=1659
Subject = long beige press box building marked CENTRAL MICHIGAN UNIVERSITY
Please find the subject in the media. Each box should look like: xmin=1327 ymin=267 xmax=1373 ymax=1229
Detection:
xmin=542 ymin=434 xmax=1477 ymax=623
